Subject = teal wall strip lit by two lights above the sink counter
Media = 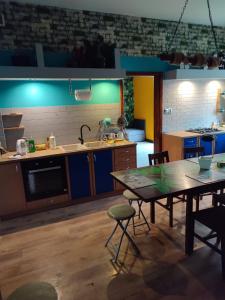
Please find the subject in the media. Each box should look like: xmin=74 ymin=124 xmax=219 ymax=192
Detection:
xmin=0 ymin=80 xmax=120 ymax=108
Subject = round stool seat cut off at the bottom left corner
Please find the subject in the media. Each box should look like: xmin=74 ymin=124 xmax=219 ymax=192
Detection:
xmin=7 ymin=282 xmax=58 ymax=300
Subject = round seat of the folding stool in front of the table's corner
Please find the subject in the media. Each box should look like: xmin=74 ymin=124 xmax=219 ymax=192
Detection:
xmin=108 ymin=204 xmax=136 ymax=221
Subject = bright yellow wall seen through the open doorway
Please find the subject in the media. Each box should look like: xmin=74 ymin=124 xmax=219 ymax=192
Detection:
xmin=133 ymin=76 xmax=154 ymax=140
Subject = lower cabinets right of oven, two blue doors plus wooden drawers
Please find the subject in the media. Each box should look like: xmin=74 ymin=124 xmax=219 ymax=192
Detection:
xmin=68 ymin=145 xmax=136 ymax=199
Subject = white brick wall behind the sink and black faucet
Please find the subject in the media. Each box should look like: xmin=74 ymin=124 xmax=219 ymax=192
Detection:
xmin=0 ymin=103 xmax=120 ymax=145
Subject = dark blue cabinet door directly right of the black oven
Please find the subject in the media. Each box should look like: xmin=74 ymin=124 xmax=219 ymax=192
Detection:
xmin=68 ymin=153 xmax=91 ymax=199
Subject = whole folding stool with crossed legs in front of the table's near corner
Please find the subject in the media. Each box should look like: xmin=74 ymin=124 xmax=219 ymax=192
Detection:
xmin=105 ymin=204 xmax=140 ymax=263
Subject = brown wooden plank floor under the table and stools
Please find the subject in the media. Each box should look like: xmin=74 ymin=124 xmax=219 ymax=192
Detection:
xmin=0 ymin=197 xmax=225 ymax=300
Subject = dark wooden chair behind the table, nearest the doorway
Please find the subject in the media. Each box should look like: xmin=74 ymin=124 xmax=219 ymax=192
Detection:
xmin=148 ymin=151 xmax=178 ymax=227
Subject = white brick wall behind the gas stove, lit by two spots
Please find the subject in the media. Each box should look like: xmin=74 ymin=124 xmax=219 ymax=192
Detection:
xmin=163 ymin=79 xmax=225 ymax=132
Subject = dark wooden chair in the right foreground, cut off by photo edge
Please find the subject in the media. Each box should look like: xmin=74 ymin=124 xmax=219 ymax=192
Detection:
xmin=190 ymin=194 xmax=225 ymax=279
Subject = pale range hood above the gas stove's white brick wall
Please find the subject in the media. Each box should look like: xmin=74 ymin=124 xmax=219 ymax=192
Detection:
xmin=164 ymin=69 xmax=225 ymax=80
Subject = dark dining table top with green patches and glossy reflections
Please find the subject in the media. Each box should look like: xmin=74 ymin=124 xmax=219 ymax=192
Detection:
xmin=111 ymin=154 xmax=225 ymax=202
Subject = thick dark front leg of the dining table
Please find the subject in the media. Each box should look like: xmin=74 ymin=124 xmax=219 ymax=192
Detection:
xmin=185 ymin=194 xmax=194 ymax=255
